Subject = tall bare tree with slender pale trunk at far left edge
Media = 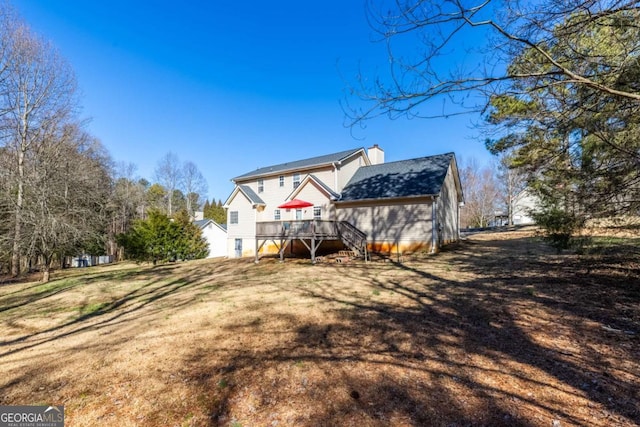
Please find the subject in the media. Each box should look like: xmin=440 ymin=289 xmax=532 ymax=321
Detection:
xmin=0 ymin=5 xmax=76 ymax=275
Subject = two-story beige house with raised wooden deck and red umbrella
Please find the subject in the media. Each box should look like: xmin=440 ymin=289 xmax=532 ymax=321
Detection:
xmin=225 ymin=145 xmax=462 ymax=260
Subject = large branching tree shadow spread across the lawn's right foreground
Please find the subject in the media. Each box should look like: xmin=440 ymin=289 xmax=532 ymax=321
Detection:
xmin=187 ymin=236 xmax=640 ymax=426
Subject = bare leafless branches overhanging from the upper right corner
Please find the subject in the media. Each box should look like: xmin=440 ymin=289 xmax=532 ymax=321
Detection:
xmin=347 ymin=0 xmax=640 ymax=125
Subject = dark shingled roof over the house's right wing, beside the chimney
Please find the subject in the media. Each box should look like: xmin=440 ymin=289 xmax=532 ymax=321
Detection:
xmin=339 ymin=153 xmax=454 ymax=202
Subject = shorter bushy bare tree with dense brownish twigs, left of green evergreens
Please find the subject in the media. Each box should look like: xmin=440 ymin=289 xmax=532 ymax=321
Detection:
xmin=23 ymin=124 xmax=110 ymax=282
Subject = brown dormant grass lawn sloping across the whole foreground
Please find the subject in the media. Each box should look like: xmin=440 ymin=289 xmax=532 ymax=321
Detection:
xmin=0 ymin=232 xmax=640 ymax=427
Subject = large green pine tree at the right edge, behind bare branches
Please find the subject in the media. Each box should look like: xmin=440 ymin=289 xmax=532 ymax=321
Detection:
xmin=487 ymin=10 xmax=640 ymax=223
